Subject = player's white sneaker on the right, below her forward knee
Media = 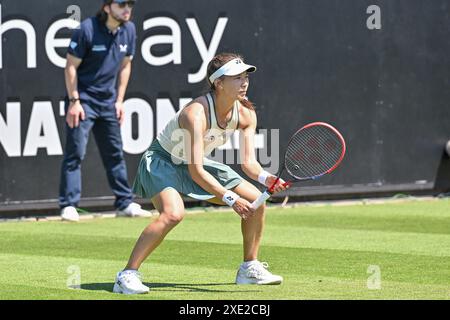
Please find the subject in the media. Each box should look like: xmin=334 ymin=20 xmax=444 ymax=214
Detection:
xmin=236 ymin=261 xmax=283 ymax=284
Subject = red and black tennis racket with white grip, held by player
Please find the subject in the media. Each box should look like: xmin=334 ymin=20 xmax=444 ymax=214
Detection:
xmin=252 ymin=122 xmax=346 ymax=210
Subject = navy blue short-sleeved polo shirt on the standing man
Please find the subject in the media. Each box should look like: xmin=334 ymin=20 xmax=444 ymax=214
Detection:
xmin=67 ymin=17 xmax=136 ymax=105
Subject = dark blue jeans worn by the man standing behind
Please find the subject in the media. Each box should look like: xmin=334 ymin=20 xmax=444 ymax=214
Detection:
xmin=59 ymin=103 xmax=133 ymax=209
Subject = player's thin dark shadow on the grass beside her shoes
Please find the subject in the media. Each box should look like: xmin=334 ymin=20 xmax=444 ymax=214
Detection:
xmin=80 ymin=282 xmax=258 ymax=292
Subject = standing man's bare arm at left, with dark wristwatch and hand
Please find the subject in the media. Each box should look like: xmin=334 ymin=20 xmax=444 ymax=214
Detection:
xmin=64 ymin=54 xmax=85 ymax=128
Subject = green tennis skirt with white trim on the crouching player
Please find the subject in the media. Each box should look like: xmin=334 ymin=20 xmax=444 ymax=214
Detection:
xmin=133 ymin=139 xmax=243 ymax=200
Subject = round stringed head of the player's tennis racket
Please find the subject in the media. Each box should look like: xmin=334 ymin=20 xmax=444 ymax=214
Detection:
xmin=285 ymin=126 xmax=345 ymax=179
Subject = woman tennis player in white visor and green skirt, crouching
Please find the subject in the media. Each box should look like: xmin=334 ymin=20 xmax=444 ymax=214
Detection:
xmin=114 ymin=53 xmax=287 ymax=294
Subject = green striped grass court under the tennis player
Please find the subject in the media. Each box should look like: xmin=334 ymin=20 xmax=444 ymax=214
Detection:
xmin=0 ymin=199 xmax=450 ymax=300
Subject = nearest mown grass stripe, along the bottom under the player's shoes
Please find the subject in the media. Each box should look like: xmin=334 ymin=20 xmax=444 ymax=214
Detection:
xmin=0 ymin=254 xmax=450 ymax=300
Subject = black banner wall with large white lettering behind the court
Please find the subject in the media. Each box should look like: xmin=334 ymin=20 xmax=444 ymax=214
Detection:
xmin=0 ymin=0 xmax=450 ymax=212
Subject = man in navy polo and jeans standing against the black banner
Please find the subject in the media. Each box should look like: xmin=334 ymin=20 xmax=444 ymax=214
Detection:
xmin=59 ymin=0 xmax=146 ymax=221
